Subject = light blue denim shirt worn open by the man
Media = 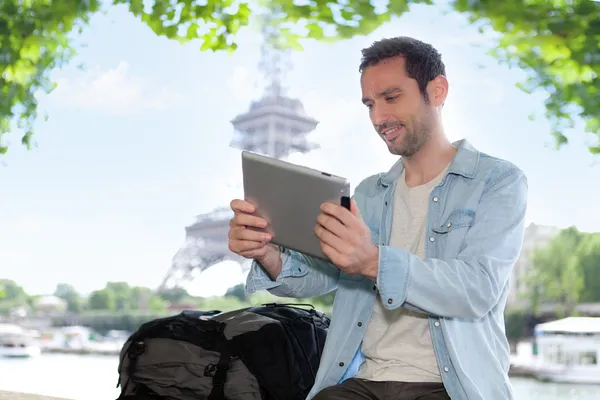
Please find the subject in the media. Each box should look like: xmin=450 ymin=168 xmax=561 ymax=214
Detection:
xmin=247 ymin=140 xmax=528 ymax=400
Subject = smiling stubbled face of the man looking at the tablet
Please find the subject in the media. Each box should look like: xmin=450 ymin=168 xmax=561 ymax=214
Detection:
xmin=361 ymin=57 xmax=434 ymax=158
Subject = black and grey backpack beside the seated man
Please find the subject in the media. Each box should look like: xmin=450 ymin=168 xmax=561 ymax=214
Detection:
xmin=117 ymin=303 xmax=330 ymax=400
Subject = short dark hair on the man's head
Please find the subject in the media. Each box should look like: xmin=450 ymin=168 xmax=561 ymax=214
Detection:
xmin=359 ymin=36 xmax=446 ymax=102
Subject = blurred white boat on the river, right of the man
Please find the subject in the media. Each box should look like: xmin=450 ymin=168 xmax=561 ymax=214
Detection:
xmin=534 ymin=317 xmax=600 ymax=384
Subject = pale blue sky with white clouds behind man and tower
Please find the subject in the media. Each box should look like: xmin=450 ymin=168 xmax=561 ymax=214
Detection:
xmin=0 ymin=6 xmax=600 ymax=296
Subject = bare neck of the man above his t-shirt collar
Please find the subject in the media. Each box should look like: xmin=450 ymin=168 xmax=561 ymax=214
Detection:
xmin=402 ymin=132 xmax=456 ymax=187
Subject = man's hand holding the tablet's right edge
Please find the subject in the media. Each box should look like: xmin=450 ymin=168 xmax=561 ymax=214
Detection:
xmin=315 ymin=200 xmax=379 ymax=280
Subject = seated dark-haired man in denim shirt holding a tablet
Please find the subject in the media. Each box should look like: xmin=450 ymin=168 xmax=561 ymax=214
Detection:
xmin=229 ymin=37 xmax=527 ymax=400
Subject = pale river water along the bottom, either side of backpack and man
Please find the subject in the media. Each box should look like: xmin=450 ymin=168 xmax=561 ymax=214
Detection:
xmin=0 ymin=354 xmax=600 ymax=400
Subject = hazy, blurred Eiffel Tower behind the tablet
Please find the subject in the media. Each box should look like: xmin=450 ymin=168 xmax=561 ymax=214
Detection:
xmin=159 ymin=23 xmax=319 ymax=290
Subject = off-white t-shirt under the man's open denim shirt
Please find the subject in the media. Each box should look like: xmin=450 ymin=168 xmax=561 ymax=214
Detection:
xmin=356 ymin=166 xmax=446 ymax=382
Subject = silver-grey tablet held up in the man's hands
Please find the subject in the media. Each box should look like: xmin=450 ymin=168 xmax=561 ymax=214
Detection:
xmin=242 ymin=151 xmax=350 ymax=261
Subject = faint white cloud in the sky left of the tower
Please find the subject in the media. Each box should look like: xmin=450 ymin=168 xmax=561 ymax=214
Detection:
xmin=52 ymin=61 xmax=183 ymax=115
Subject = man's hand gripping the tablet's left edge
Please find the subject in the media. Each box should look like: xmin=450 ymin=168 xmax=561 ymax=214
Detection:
xmin=228 ymin=199 xmax=281 ymax=280
